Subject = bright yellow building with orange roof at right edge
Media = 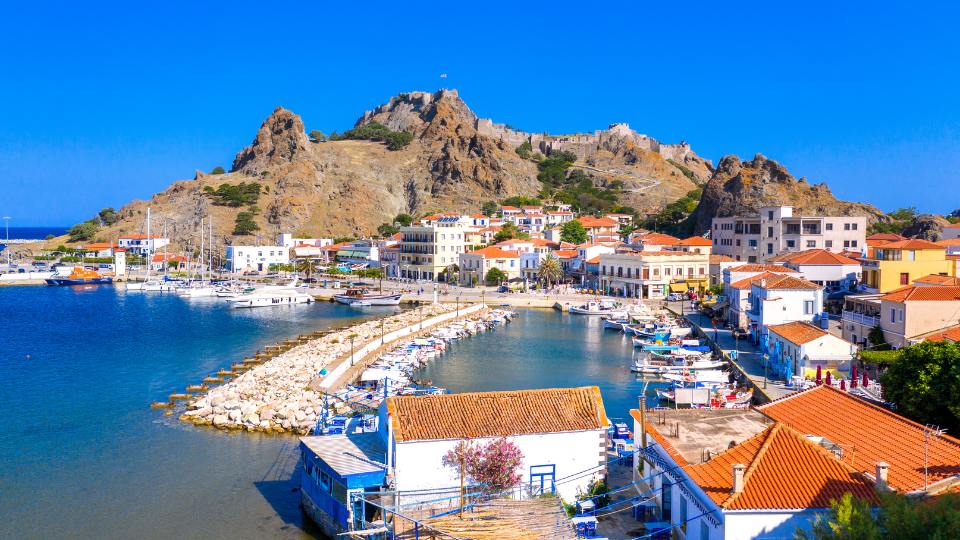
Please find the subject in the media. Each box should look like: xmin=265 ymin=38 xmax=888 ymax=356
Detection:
xmin=862 ymin=239 xmax=955 ymax=293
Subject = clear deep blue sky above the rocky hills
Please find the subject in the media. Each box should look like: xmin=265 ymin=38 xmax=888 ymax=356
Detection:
xmin=0 ymin=1 xmax=960 ymax=226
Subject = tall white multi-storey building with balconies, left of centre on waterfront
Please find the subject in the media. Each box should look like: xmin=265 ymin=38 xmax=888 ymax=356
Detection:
xmin=399 ymin=216 xmax=466 ymax=281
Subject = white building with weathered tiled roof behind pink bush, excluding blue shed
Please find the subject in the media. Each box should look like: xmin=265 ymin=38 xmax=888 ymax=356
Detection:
xmin=379 ymin=386 xmax=610 ymax=501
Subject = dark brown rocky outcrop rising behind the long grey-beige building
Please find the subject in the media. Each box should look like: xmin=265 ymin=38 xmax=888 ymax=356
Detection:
xmin=692 ymin=154 xmax=888 ymax=234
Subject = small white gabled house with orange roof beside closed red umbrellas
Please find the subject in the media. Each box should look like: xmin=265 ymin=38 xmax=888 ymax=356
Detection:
xmin=768 ymin=322 xmax=857 ymax=380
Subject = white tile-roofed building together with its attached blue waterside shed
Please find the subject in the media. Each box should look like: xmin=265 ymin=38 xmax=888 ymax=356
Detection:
xmin=300 ymin=386 xmax=610 ymax=536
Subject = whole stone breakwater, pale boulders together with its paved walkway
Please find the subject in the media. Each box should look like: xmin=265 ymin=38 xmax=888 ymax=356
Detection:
xmin=180 ymin=304 xmax=496 ymax=434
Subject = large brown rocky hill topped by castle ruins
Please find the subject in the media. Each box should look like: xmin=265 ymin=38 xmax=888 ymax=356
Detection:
xmin=51 ymin=90 xmax=713 ymax=247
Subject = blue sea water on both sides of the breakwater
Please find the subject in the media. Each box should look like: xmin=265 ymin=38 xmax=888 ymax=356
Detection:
xmin=0 ymin=286 xmax=660 ymax=539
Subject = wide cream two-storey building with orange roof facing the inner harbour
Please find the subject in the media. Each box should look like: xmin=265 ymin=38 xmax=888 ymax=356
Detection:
xmin=599 ymin=251 xmax=710 ymax=298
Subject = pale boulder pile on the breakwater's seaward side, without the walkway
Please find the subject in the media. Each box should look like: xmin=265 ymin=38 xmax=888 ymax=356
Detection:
xmin=180 ymin=304 xmax=463 ymax=434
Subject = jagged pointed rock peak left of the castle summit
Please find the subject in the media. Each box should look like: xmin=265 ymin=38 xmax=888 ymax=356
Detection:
xmin=233 ymin=107 xmax=309 ymax=176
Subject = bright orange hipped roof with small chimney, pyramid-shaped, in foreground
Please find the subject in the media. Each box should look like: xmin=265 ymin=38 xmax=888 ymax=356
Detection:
xmin=686 ymin=423 xmax=877 ymax=510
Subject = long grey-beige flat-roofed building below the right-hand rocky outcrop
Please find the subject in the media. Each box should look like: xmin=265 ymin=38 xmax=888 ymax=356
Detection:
xmin=711 ymin=206 xmax=867 ymax=262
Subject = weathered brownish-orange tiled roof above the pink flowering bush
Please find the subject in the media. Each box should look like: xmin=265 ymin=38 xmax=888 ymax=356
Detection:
xmin=387 ymin=386 xmax=610 ymax=442
